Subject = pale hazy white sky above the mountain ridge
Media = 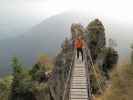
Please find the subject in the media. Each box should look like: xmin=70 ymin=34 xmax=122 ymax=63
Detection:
xmin=0 ymin=0 xmax=133 ymax=37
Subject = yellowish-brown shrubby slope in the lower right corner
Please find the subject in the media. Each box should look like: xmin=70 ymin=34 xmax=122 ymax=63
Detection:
xmin=103 ymin=64 xmax=133 ymax=100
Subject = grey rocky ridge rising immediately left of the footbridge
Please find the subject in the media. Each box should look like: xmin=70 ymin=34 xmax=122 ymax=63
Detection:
xmin=48 ymin=37 xmax=74 ymax=100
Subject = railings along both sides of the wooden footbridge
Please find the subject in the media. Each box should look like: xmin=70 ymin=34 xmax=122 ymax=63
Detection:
xmin=62 ymin=40 xmax=103 ymax=100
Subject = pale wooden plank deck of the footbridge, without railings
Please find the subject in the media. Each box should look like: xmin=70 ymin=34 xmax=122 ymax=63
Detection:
xmin=69 ymin=56 xmax=89 ymax=100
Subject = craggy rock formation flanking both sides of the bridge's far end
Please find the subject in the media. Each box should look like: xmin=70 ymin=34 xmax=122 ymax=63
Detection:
xmin=31 ymin=19 xmax=118 ymax=100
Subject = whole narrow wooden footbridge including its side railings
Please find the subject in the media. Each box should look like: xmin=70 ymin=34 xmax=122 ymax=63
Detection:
xmin=63 ymin=47 xmax=102 ymax=100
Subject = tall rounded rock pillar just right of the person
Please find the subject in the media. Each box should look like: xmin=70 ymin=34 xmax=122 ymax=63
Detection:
xmin=86 ymin=19 xmax=106 ymax=61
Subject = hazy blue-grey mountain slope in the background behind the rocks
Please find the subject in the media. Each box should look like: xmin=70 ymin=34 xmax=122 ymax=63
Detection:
xmin=0 ymin=12 xmax=133 ymax=75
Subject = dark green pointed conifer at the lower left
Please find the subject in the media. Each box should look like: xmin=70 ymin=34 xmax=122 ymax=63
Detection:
xmin=9 ymin=57 xmax=35 ymax=100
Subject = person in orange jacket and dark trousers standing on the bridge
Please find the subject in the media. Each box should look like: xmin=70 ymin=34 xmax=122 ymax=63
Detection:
xmin=75 ymin=36 xmax=84 ymax=61
